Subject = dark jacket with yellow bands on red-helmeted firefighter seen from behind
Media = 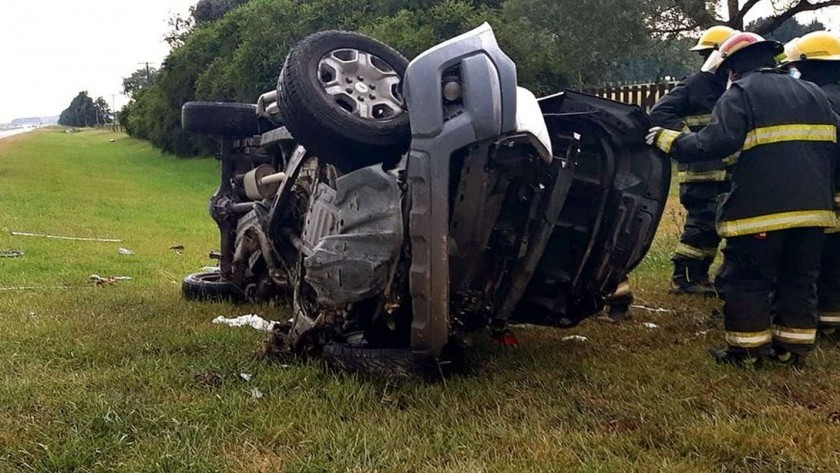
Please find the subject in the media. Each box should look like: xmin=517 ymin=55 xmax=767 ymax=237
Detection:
xmin=665 ymin=70 xmax=840 ymax=237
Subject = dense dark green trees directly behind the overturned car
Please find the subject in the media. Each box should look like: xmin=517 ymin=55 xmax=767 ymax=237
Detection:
xmin=120 ymin=0 xmax=840 ymax=155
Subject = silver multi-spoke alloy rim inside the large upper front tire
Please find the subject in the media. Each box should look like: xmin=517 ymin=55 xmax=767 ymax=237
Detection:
xmin=318 ymin=48 xmax=405 ymax=120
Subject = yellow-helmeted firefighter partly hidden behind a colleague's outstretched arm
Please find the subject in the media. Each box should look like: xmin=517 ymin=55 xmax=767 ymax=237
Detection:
xmin=650 ymin=26 xmax=735 ymax=295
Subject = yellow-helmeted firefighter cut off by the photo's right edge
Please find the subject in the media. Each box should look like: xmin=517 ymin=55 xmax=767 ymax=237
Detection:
xmin=785 ymin=31 xmax=840 ymax=333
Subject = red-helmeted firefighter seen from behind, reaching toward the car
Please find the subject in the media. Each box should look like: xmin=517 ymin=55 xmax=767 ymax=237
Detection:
xmin=647 ymin=33 xmax=838 ymax=367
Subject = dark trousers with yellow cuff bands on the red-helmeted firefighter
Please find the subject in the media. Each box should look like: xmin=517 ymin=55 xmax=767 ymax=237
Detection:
xmin=718 ymin=227 xmax=825 ymax=356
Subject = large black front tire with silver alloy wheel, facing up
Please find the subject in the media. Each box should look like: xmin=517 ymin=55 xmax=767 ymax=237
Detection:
xmin=277 ymin=31 xmax=411 ymax=172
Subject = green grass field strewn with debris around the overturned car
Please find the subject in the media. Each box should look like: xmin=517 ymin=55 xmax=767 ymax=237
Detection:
xmin=0 ymin=130 xmax=840 ymax=472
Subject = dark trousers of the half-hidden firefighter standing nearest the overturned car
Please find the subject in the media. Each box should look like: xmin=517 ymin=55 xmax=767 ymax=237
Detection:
xmin=672 ymin=182 xmax=728 ymax=283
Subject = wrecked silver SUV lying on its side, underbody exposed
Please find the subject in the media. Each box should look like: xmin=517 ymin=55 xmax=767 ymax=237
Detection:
xmin=182 ymin=24 xmax=670 ymax=374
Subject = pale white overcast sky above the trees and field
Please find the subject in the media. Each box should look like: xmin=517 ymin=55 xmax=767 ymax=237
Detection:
xmin=0 ymin=0 xmax=840 ymax=123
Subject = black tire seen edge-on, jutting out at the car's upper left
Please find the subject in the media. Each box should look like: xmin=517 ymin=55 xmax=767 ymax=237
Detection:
xmin=181 ymin=102 xmax=260 ymax=138
